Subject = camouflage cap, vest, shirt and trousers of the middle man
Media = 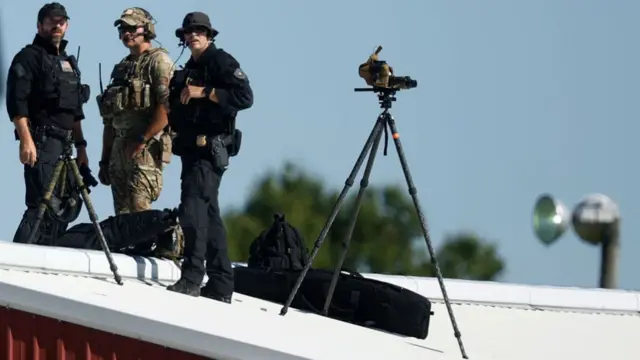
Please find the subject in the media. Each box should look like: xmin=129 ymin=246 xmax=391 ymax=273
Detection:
xmin=99 ymin=8 xmax=173 ymax=214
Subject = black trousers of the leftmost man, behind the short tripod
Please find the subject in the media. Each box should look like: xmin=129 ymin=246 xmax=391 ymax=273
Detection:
xmin=13 ymin=137 xmax=68 ymax=245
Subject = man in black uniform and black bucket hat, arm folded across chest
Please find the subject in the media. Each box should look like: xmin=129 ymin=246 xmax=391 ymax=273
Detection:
xmin=167 ymin=12 xmax=253 ymax=303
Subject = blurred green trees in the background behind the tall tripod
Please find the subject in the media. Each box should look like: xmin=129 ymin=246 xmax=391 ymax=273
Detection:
xmin=224 ymin=163 xmax=504 ymax=280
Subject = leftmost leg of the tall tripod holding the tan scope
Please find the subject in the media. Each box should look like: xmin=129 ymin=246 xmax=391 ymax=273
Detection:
xmin=280 ymin=117 xmax=385 ymax=315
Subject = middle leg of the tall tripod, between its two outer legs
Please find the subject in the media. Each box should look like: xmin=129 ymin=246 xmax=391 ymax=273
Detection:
xmin=322 ymin=122 xmax=382 ymax=316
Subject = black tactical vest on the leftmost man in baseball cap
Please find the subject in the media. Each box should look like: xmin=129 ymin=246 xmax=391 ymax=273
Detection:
xmin=29 ymin=45 xmax=90 ymax=111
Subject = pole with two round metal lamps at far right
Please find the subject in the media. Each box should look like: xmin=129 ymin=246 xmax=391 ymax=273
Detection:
xmin=533 ymin=194 xmax=620 ymax=289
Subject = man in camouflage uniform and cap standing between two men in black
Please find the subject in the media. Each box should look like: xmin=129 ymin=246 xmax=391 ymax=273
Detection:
xmin=97 ymin=7 xmax=177 ymax=255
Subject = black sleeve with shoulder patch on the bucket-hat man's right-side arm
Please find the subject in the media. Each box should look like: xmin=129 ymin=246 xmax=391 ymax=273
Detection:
xmin=213 ymin=50 xmax=253 ymax=113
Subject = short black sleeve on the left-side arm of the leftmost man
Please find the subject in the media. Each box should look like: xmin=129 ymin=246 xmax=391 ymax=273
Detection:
xmin=6 ymin=49 xmax=38 ymax=121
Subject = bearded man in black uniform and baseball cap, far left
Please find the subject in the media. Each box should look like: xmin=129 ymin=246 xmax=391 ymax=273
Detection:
xmin=6 ymin=2 xmax=89 ymax=245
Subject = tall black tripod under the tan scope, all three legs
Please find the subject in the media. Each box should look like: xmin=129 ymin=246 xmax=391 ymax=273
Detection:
xmin=280 ymin=87 xmax=468 ymax=359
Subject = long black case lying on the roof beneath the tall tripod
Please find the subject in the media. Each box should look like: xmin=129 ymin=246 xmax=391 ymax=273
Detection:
xmin=234 ymin=267 xmax=433 ymax=339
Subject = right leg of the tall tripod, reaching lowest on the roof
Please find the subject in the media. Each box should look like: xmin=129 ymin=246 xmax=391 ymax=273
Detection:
xmin=387 ymin=114 xmax=468 ymax=359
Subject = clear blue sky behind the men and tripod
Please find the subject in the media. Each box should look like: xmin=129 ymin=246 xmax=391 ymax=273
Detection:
xmin=0 ymin=0 xmax=640 ymax=289
